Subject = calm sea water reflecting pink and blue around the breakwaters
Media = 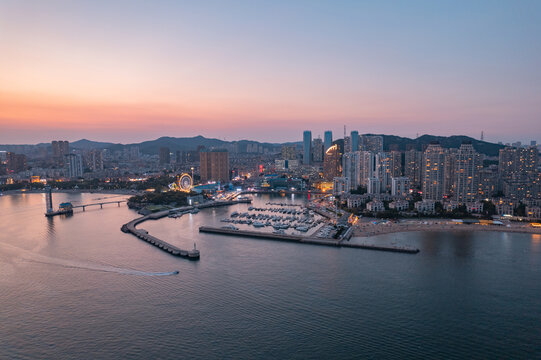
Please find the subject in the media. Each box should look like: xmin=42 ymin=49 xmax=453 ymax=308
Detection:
xmin=0 ymin=194 xmax=541 ymax=359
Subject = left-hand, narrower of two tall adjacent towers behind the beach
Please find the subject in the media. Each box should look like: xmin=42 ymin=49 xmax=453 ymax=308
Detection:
xmin=422 ymin=142 xmax=445 ymax=201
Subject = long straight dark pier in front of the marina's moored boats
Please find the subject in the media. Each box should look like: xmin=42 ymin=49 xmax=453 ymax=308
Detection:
xmin=199 ymin=226 xmax=419 ymax=254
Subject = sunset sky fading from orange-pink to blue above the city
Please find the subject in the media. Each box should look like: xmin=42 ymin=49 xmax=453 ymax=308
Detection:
xmin=0 ymin=0 xmax=541 ymax=144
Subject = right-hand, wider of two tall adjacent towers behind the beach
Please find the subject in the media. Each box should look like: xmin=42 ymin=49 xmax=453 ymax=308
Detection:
xmin=454 ymin=142 xmax=482 ymax=205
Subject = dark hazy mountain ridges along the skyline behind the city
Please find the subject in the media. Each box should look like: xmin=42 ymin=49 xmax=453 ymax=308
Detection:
xmin=0 ymin=134 xmax=504 ymax=156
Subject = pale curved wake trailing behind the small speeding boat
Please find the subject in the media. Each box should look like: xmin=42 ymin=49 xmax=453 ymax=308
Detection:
xmin=0 ymin=243 xmax=179 ymax=276
